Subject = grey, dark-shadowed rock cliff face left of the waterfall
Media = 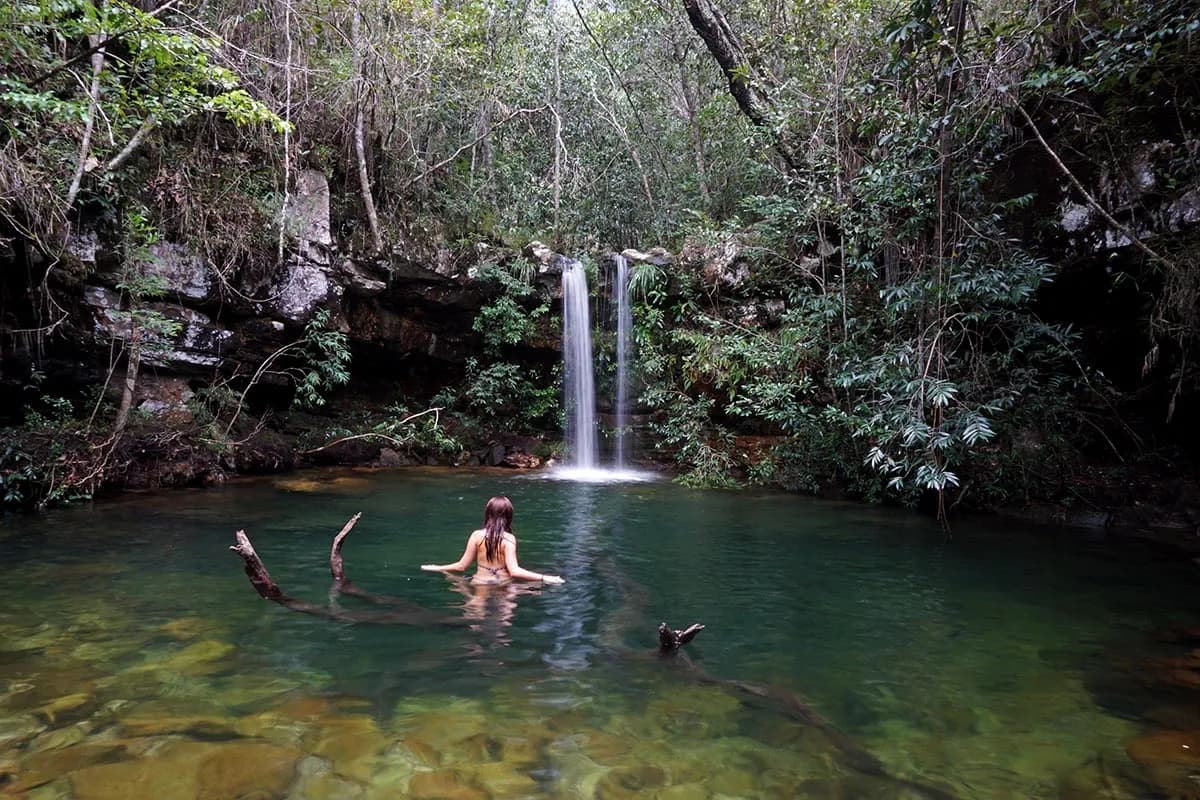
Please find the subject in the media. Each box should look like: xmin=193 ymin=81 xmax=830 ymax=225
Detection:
xmin=0 ymin=170 xmax=558 ymax=422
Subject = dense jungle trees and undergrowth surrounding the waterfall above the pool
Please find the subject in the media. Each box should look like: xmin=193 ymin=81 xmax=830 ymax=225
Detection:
xmin=0 ymin=0 xmax=1200 ymax=520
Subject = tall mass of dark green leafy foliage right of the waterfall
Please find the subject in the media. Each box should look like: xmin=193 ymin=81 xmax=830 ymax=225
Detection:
xmin=624 ymin=2 xmax=1094 ymax=503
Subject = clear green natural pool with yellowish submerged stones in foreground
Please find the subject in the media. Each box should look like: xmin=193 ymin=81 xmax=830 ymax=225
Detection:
xmin=0 ymin=470 xmax=1200 ymax=800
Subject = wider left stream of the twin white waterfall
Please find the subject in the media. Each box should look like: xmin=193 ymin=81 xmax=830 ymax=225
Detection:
xmin=563 ymin=259 xmax=596 ymax=469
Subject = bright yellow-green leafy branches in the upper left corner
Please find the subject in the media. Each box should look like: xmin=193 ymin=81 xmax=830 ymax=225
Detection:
xmin=0 ymin=0 xmax=289 ymax=248
